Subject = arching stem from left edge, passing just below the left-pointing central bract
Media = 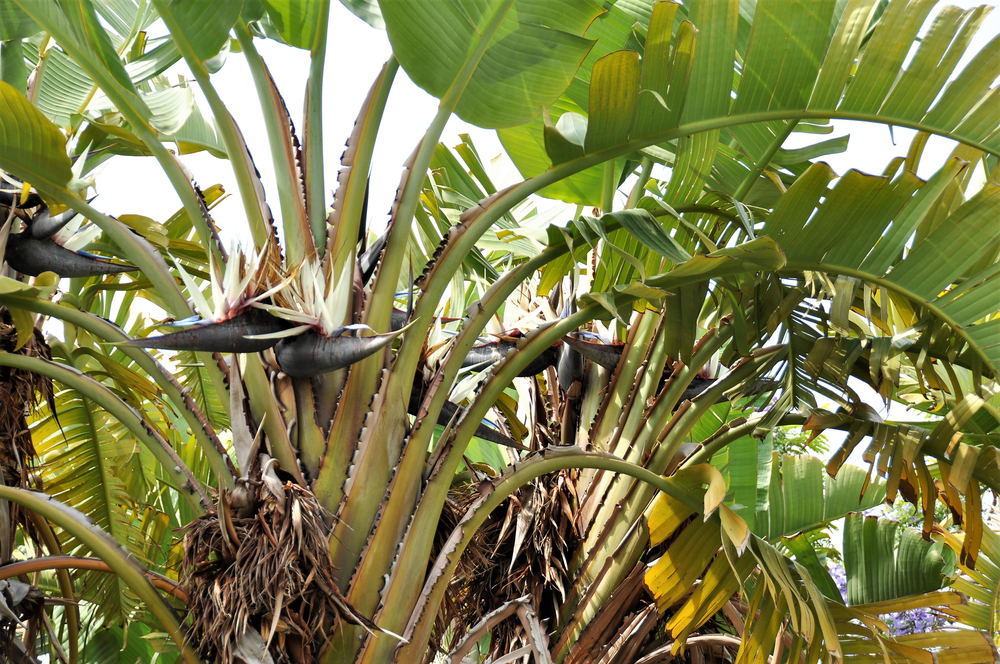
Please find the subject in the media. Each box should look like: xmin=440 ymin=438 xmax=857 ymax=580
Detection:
xmin=0 ymin=295 xmax=235 ymax=489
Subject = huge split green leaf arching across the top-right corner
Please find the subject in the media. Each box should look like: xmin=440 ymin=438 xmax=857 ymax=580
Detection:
xmin=500 ymin=0 xmax=1000 ymax=204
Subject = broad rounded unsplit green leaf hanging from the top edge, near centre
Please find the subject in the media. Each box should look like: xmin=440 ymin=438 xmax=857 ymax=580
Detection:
xmin=380 ymin=0 xmax=602 ymax=128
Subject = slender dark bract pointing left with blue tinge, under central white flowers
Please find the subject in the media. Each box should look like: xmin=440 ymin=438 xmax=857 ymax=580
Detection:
xmin=124 ymin=308 xmax=292 ymax=353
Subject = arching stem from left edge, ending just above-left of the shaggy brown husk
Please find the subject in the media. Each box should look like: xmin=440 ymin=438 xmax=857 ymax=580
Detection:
xmin=0 ymin=352 xmax=212 ymax=515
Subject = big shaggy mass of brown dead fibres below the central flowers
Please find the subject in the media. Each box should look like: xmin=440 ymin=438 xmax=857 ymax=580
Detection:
xmin=181 ymin=482 xmax=374 ymax=664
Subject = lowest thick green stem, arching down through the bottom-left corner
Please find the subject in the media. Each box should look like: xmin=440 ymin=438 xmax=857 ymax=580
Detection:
xmin=0 ymin=486 xmax=201 ymax=664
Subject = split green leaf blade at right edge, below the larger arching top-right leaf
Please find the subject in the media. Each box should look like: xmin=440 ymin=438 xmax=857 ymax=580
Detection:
xmin=762 ymin=159 xmax=1000 ymax=382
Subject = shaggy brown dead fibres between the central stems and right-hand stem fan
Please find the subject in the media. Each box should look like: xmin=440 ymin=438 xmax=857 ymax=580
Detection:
xmin=431 ymin=471 xmax=580 ymax=654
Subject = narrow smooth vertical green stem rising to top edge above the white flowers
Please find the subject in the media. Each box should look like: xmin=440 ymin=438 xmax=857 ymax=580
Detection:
xmin=302 ymin=0 xmax=330 ymax=258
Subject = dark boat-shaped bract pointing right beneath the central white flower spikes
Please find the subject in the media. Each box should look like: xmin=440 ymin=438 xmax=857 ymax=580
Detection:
xmin=274 ymin=330 xmax=399 ymax=378
